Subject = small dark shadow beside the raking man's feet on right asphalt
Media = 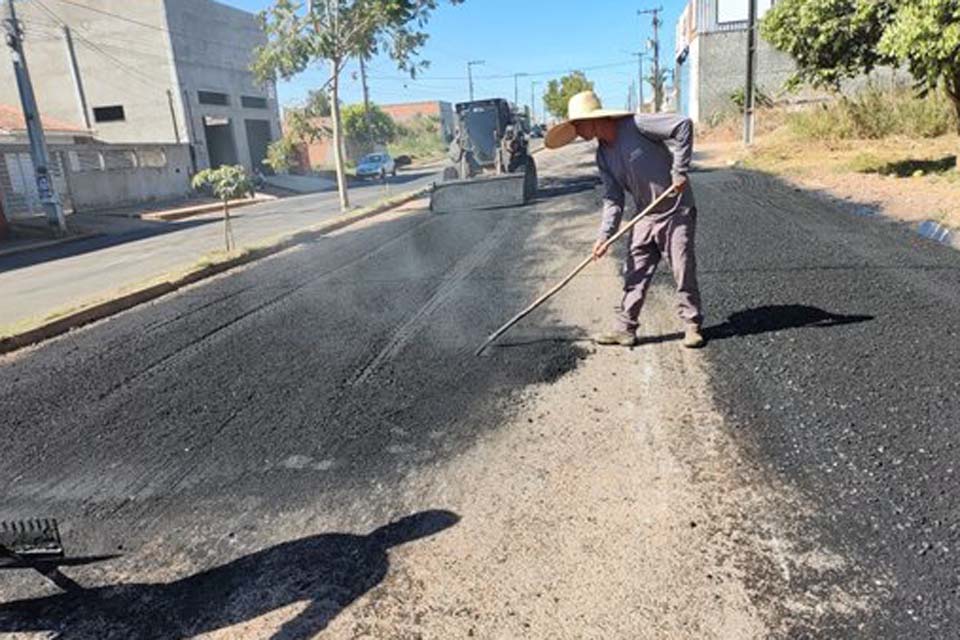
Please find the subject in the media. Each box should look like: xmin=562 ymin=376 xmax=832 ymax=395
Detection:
xmin=639 ymin=304 xmax=873 ymax=345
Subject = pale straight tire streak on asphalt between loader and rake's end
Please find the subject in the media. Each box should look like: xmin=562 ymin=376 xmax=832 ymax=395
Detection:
xmin=349 ymin=217 xmax=511 ymax=387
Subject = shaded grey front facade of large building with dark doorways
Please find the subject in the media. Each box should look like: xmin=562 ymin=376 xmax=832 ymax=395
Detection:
xmin=166 ymin=0 xmax=281 ymax=170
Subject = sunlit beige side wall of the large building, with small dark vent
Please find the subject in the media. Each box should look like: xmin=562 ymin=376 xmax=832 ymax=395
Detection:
xmin=0 ymin=0 xmax=182 ymax=143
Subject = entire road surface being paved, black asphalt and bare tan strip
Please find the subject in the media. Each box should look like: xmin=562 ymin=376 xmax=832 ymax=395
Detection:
xmin=0 ymin=145 xmax=960 ymax=638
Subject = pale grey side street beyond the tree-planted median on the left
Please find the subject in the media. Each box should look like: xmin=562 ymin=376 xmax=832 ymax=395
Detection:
xmin=0 ymin=171 xmax=436 ymax=334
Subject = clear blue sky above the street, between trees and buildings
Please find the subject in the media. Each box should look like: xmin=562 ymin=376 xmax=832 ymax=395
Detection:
xmin=219 ymin=0 xmax=686 ymax=113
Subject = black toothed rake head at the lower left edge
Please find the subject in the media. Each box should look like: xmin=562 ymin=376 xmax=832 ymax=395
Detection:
xmin=0 ymin=518 xmax=117 ymax=591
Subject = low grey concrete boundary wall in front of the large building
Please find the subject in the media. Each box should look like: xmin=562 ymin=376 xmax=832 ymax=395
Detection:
xmin=67 ymin=145 xmax=190 ymax=211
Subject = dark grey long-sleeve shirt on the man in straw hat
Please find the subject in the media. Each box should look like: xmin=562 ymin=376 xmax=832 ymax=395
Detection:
xmin=597 ymin=113 xmax=695 ymax=240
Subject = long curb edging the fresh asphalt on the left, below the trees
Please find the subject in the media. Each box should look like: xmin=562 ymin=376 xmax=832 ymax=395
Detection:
xmin=0 ymin=185 xmax=433 ymax=355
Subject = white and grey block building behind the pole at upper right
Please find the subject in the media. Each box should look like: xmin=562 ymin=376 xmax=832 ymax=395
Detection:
xmin=675 ymin=0 xmax=796 ymax=122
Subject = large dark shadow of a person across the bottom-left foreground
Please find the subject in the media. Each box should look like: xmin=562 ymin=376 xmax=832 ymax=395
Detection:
xmin=0 ymin=511 xmax=460 ymax=640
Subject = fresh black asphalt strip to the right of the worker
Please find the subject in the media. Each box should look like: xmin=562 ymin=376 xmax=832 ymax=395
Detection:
xmin=698 ymin=172 xmax=960 ymax=638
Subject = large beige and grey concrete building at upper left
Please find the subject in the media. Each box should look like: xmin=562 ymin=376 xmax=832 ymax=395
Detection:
xmin=0 ymin=0 xmax=281 ymax=175
